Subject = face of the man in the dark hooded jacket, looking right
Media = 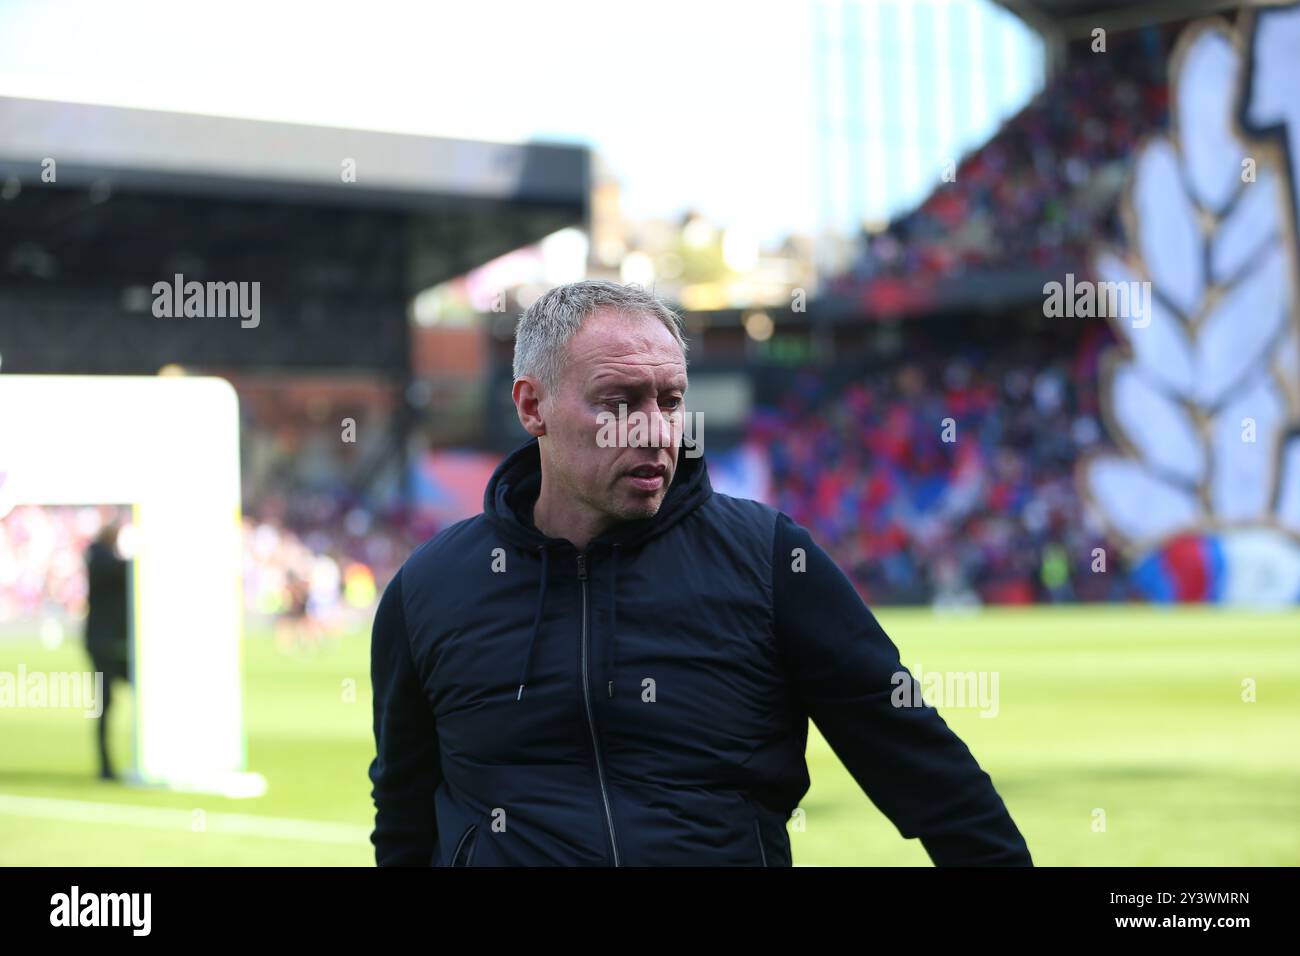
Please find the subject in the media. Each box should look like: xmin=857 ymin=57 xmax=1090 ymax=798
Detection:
xmin=541 ymin=311 xmax=686 ymax=522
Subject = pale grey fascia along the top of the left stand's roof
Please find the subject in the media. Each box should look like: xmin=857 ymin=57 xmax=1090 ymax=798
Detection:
xmin=0 ymin=96 xmax=588 ymax=207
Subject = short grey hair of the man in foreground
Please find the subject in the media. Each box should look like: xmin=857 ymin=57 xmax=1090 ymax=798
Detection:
xmin=515 ymin=278 xmax=686 ymax=390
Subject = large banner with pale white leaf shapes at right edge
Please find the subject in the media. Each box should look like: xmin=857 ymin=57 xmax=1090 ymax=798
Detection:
xmin=1079 ymin=4 xmax=1300 ymax=605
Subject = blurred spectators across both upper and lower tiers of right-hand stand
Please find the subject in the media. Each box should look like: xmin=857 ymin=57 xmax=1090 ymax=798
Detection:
xmin=769 ymin=23 xmax=1179 ymax=605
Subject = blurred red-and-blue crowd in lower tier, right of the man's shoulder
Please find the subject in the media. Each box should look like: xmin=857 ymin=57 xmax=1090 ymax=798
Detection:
xmin=748 ymin=325 xmax=1132 ymax=605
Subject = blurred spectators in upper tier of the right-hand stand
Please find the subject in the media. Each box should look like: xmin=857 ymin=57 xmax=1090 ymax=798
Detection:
xmin=829 ymin=26 xmax=1174 ymax=287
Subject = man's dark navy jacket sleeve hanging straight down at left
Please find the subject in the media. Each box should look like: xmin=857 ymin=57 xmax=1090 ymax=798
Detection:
xmin=369 ymin=571 xmax=442 ymax=866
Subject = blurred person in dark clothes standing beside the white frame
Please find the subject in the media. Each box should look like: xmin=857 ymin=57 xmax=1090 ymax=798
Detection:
xmin=86 ymin=519 xmax=130 ymax=780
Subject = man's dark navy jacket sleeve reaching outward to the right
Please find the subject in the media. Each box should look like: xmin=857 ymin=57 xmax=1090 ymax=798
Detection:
xmin=772 ymin=514 xmax=1034 ymax=866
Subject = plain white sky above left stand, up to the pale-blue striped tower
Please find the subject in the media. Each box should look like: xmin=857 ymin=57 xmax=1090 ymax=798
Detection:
xmin=0 ymin=0 xmax=816 ymax=239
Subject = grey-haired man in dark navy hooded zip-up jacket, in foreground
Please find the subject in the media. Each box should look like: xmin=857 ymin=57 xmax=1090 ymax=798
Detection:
xmin=369 ymin=281 xmax=1031 ymax=866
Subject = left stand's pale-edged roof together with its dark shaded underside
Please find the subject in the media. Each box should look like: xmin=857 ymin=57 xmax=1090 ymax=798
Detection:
xmin=0 ymin=96 xmax=589 ymax=375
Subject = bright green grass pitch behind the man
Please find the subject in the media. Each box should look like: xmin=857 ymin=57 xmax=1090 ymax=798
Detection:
xmin=0 ymin=607 xmax=1300 ymax=866
